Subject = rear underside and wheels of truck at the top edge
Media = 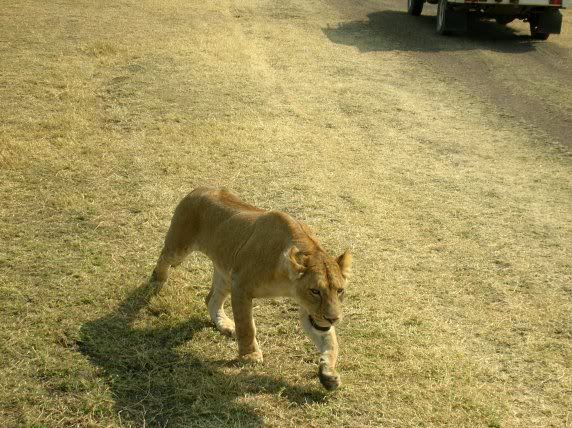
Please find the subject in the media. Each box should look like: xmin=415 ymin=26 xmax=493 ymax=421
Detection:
xmin=407 ymin=0 xmax=571 ymax=40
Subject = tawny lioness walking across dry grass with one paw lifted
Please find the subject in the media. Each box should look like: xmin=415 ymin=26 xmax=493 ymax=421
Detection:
xmin=153 ymin=188 xmax=352 ymax=390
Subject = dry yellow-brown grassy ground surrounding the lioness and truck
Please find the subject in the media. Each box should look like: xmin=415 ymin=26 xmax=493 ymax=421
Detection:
xmin=0 ymin=0 xmax=572 ymax=428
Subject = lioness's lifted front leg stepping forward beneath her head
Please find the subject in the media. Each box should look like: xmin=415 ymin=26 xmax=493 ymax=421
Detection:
xmin=300 ymin=308 xmax=341 ymax=391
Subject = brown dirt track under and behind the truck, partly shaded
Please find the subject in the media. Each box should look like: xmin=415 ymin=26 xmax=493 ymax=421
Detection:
xmin=325 ymin=1 xmax=572 ymax=143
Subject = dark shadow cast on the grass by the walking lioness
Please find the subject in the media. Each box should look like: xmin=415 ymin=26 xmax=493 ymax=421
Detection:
xmin=78 ymin=282 xmax=325 ymax=427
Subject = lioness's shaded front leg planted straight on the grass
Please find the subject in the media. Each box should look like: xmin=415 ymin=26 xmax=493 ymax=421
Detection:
xmin=231 ymin=280 xmax=262 ymax=363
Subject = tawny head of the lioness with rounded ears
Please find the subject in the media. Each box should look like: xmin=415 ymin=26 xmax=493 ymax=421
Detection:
xmin=285 ymin=246 xmax=352 ymax=330
